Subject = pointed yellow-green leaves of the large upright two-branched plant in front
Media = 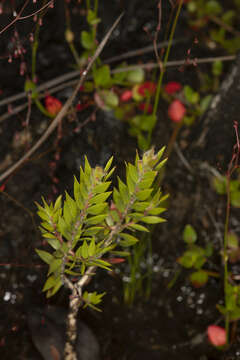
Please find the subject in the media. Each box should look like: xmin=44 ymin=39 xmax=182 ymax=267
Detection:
xmin=36 ymin=148 xmax=166 ymax=308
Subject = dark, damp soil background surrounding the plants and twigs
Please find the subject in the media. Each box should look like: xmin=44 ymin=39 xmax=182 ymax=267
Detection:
xmin=0 ymin=0 xmax=240 ymax=360
